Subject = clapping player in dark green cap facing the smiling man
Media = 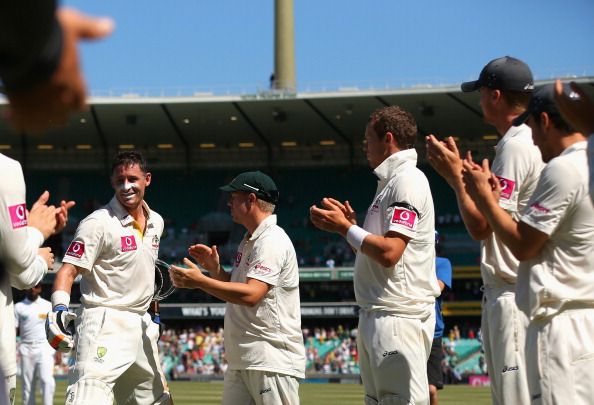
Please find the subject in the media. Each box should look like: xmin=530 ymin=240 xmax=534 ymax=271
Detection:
xmin=170 ymin=171 xmax=305 ymax=405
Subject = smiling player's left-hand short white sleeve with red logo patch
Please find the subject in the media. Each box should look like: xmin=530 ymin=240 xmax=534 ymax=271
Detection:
xmin=62 ymin=216 xmax=104 ymax=270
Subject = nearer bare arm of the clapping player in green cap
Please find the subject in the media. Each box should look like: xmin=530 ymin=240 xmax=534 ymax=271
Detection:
xmin=169 ymin=258 xmax=271 ymax=307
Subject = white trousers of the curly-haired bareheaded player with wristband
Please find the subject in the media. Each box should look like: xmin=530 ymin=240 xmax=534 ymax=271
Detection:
xmin=357 ymin=310 xmax=435 ymax=405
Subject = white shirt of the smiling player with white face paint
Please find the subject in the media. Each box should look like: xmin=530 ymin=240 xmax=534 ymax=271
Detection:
xmin=62 ymin=197 xmax=163 ymax=313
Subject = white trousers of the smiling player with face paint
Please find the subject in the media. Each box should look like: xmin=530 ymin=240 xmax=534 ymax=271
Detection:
xmin=66 ymin=307 xmax=169 ymax=405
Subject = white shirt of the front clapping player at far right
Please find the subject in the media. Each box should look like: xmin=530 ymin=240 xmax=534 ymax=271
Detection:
xmin=516 ymin=141 xmax=594 ymax=319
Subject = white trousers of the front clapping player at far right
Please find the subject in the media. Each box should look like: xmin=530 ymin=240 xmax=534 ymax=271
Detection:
xmin=526 ymin=308 xmax=594 ymax=405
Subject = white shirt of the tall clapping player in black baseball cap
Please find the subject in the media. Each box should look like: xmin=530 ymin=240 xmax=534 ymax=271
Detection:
xmin=481 ymin=124 xmax=544 ymax=287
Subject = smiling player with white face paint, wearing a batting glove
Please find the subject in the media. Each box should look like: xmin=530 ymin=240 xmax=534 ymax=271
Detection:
xmin=46 ymin=151 xmax=171 ymax=405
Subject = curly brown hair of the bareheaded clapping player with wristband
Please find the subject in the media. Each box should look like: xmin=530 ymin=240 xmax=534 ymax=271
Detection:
xmin=368 ymin=105 xmax=418 ymax=150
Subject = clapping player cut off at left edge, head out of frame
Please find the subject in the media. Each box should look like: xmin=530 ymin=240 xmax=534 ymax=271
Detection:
xmin=0 ymin=154 xmax=74 ymax=404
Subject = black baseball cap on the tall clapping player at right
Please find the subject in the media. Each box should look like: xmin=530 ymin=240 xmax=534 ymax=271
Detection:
xmin=460 ymin=56 xmax=534 ymax=92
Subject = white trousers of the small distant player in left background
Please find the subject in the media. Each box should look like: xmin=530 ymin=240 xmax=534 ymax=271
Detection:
xmin=19 ymin=340 xmax=56 ymax=405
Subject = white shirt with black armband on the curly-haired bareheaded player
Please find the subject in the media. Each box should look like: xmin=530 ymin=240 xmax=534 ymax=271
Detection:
xmin=353 ymin=149 xmax=440 ymax=319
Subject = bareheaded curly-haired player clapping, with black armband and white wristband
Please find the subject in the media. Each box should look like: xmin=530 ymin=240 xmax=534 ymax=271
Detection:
xmin=310 ymin=106 xmax=440 ymax=405
